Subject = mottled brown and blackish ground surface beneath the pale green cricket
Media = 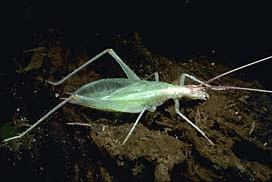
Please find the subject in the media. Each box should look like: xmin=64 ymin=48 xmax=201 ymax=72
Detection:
xmin=0 ymin=29 xmax=272 ymax=181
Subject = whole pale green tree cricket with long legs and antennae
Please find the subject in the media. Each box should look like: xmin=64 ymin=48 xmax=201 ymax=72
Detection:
xmin=4 ymin=49 xmax=272 ymax=145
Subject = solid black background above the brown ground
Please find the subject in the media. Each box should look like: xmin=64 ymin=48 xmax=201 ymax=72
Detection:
xmin=0 ymin=0 xmax=272 ymax=88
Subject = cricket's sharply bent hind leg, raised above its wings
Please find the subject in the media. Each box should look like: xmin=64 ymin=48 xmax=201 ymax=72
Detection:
xmin=46 ymin=49 xmax=140 ymax=86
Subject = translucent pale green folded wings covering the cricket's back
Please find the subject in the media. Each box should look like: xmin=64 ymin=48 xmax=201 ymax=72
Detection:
xmin=70 ymin=78 xmax=172 ymax=113
